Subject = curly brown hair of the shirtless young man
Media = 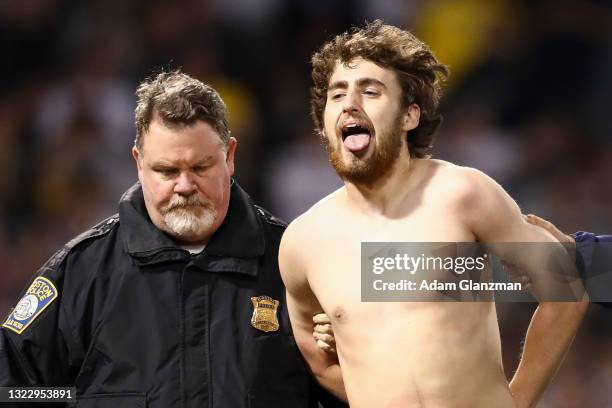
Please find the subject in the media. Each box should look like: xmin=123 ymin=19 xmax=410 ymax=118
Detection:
xmin=310 ymin=20 xmax=449 ymax=158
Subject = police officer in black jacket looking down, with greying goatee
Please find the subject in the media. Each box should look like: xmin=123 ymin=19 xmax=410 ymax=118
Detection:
xmin=0 ymin=71 xmax=344 ymax=408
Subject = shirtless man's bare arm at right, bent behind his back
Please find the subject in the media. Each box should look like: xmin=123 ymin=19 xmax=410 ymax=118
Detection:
xmin=462 ymin=169 xmax=588 ymax=408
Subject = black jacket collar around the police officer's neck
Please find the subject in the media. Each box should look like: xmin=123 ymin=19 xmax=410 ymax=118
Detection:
xmin=119 ymin=182 xmax=265 ymax=263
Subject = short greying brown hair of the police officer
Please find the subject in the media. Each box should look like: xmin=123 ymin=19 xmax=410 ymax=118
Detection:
xmin=134 ymin=70 xmax=230 ymax=151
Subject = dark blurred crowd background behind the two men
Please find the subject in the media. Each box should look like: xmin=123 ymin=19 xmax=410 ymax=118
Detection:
xmin=0 ymin=0 xmax=612 ymax=407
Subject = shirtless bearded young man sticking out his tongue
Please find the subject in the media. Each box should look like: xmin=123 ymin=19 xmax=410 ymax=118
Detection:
xmin=279 ymin=21 xmax=586 ymax=408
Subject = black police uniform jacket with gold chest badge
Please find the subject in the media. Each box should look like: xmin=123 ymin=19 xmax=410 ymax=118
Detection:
xmin=0 ymin=183 xmax=316 ymax=408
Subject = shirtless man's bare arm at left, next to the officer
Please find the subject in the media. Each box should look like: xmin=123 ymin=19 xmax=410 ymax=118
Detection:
xmin=279 ymin=220 xmax=347 ymax=401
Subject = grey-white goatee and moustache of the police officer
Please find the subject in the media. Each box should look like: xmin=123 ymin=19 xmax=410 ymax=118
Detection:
xmin=162 ymin=195 xmax=217 ymax=240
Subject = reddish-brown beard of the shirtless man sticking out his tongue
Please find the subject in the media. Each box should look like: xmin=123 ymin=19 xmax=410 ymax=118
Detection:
xmin=322 ymin=116 xmax=404 ymax=185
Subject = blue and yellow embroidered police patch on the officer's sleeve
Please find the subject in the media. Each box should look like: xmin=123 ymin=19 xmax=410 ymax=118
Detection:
xmin=2 ymin=276 xmax=57 ymax=334
